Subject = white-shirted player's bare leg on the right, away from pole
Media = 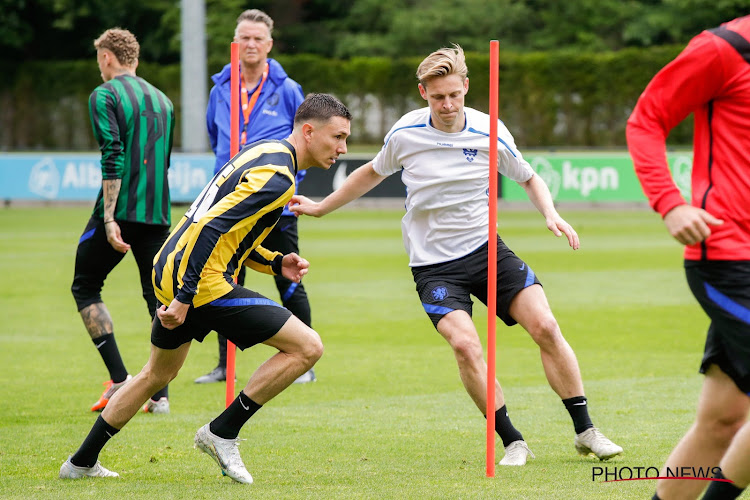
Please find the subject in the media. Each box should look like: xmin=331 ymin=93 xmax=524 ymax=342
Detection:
xmin=509 ymin=285 xmax=583 ymax=399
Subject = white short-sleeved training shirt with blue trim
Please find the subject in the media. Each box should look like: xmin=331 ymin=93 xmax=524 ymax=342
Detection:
xmin=373 ymin=108 xmax=534 ymax=267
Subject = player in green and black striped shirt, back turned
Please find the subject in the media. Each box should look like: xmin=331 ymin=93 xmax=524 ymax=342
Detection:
xmin=71 ymin=28 xmax=174 ymax=413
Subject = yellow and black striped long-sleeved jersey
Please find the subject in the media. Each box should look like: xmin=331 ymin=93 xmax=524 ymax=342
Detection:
xmin=153 ymin=140 xmax=297 ymax=307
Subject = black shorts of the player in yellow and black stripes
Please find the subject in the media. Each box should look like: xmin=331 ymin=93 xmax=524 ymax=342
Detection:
xmin=151 ymin=285 xmax=292 ymax=349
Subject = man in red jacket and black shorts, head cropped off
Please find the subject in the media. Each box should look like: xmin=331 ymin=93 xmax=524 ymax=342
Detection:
xmin=627 ymin=16 xmax=750 ymax=500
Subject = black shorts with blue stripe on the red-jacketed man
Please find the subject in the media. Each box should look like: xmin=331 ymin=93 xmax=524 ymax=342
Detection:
xmin=685 ymin=260 xmax=750 ymax=396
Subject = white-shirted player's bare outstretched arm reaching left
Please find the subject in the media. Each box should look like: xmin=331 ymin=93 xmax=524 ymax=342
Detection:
xmin=289 ymin=162 xmax=385 ymax=217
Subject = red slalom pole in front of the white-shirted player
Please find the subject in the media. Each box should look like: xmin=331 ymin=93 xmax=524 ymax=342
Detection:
xmin=487 ymin=40 xmax=500 ymax=477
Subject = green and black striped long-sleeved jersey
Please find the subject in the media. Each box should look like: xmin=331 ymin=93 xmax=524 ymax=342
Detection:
xmin=89 ymin=75 xmax=174 ymax=226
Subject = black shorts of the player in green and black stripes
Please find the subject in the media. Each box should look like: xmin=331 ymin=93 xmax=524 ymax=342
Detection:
xmin=71 ymin=217 xmax=169 ymax=317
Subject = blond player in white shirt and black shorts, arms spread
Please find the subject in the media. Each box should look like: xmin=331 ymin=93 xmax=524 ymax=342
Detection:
xmin=291 ymin=45 xmax=622 ymax=465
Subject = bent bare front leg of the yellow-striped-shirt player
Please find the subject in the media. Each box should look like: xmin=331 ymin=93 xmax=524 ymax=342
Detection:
xmin=243 ymin=316 xmax=323 ymax=405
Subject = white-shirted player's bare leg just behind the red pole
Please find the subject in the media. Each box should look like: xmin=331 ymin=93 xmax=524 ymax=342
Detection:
xmin=437 ymin=310 xmax=505 ymax=414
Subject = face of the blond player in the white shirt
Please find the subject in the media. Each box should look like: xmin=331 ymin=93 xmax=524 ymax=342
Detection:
xmin=419 ymin=74 xmax=469 ymax=132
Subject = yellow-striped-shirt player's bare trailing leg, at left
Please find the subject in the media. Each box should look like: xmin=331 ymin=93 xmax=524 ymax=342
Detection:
xmin=102 ymin=342 xmax=190 ymax=429
